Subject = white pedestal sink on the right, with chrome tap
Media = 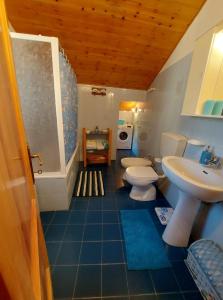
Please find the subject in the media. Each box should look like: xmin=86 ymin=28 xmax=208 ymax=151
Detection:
xmin=162 ymin=156 xmax=223 ymax=247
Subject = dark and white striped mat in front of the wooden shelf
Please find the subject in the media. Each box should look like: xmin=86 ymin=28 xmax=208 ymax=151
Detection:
xmin=74 ymin=171 xmax=105 ymax=197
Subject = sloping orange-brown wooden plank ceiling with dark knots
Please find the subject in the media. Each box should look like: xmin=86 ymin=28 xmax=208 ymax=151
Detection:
xmin=5 ymin=0 xmax=205 ymax=89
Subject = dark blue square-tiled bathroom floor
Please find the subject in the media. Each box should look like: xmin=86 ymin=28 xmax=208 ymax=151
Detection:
xmin=41 ymin=154 xmax=202 ymax=300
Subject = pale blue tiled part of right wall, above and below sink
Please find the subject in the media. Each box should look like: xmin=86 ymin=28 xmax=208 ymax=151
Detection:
xmin=147 ymin=54 xmax=223 ymax=245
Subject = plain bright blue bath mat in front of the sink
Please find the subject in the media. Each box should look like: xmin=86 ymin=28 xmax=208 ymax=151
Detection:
xmin=120 ymin=209 xmax=171 ymax=270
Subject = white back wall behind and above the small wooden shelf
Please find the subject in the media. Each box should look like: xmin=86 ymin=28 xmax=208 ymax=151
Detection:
xmin=78 ymin=84 xmax=146 ymax=159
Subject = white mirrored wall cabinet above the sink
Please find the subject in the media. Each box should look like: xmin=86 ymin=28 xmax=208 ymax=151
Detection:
xmin=182 ymin=24 xmax=223 ymax=118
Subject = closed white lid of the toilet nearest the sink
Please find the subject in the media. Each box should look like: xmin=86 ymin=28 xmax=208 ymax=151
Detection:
xmin=126 ymin=167 xmax=159 ymax=181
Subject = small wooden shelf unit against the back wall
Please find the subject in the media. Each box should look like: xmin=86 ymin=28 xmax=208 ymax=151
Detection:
xmin=82 ymin=128 xmax=112 ymax=167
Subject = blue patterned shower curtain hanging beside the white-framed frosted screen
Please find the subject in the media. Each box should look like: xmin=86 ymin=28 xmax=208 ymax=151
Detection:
xmin=60 ymin=53 xmax=78 ymax=164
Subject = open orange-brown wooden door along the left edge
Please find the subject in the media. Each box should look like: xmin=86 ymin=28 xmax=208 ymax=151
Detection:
xmin=0 ymin=0 xmax=52 ymax=300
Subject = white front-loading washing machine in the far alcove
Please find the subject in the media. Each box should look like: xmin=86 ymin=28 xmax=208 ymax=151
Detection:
xmin=117 ymin=125 xmax=133 ymax=149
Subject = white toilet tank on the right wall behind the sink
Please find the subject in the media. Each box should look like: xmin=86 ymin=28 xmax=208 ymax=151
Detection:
xmin=160 ymin=132 xmax=187 ymax=157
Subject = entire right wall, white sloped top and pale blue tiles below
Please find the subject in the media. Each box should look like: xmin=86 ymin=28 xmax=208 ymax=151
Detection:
xmin=147 ymin=0 xmax=223 ymax=245
